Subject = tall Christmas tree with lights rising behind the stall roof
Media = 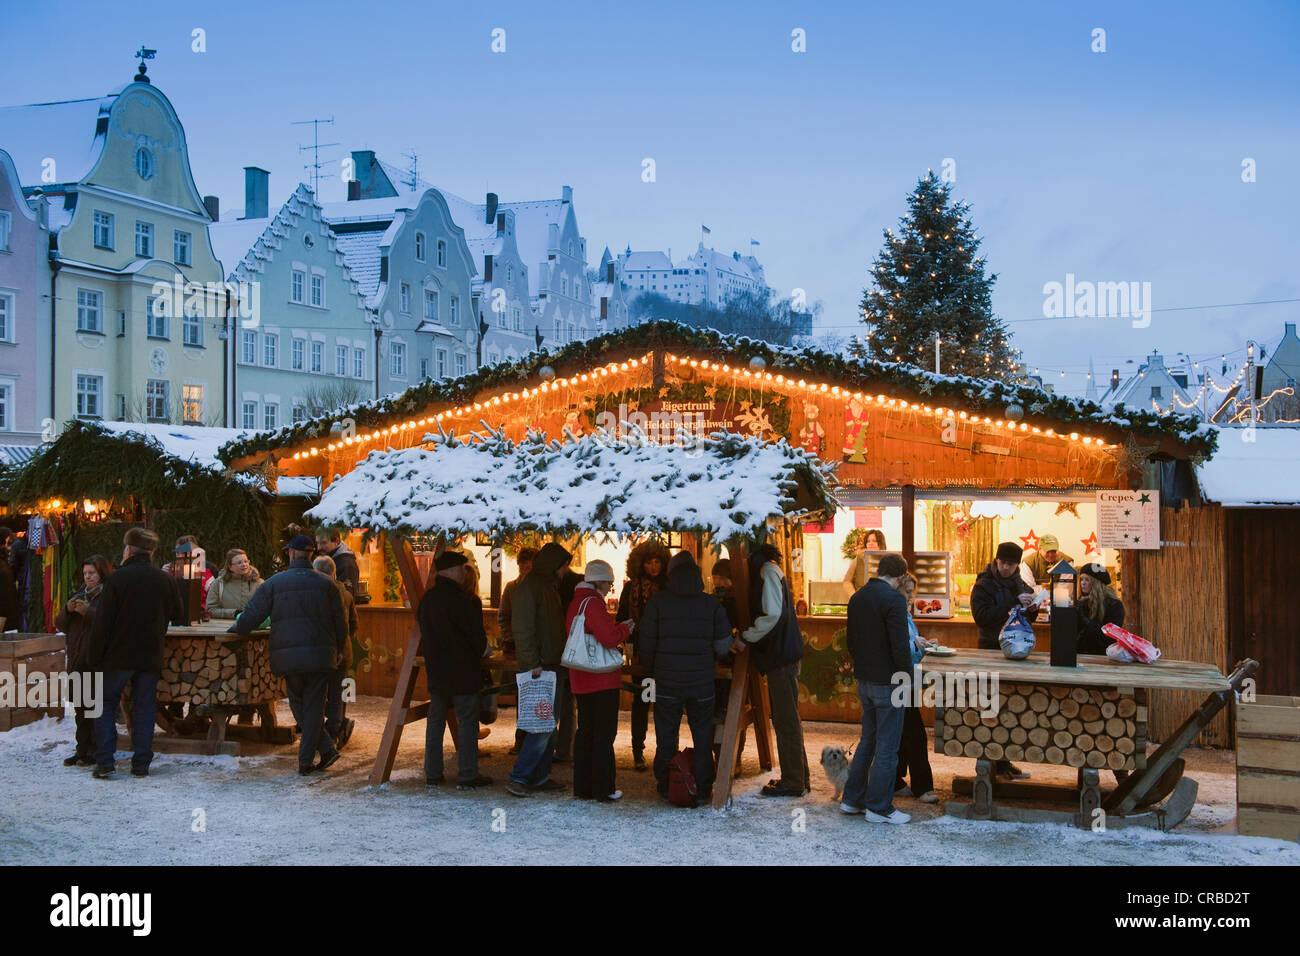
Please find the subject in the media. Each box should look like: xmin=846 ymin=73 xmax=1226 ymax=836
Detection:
xmin=862 ymin=170 xmax=1019 ymax=380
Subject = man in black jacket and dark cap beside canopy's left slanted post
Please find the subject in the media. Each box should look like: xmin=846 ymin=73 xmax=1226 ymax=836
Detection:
xmin=416 ymin=551 xmax=491 ymax=790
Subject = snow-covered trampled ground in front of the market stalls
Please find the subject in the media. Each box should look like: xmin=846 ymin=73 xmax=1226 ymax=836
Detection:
xmin=0 ymin=697 xmax=1300 ymax=865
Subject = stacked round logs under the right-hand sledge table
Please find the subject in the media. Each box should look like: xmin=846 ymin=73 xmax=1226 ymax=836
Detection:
xmin=935 ymin=684 xmax=1147 ymax=770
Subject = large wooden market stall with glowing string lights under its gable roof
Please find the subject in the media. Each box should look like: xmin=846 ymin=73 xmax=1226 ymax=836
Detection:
xmin=221 ymin=323 xmax=1229 ymax=743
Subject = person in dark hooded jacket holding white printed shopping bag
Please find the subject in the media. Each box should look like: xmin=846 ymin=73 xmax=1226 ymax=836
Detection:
xmin=506 ymin=541 xmax=571 ymax=797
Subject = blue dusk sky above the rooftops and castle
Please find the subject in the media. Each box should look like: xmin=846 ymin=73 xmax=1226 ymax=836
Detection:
xmin=0 ymin=0 xmax=1300 ymax=394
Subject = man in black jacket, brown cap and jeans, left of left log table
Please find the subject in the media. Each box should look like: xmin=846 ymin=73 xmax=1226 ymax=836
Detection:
xmin=87 ymin=528 xmax=182 ymax=780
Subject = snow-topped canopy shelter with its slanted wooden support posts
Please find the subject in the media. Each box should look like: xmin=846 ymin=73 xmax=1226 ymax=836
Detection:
xmin=301 ymin=421 xmax=836 ymax=806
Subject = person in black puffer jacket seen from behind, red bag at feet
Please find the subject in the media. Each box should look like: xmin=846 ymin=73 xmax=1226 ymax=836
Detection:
xmin=637 ymin=551 xmax=731 ymax=804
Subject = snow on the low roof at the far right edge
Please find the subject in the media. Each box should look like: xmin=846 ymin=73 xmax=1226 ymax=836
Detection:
xmin=1196 ymin=425 xmax=1300 ymax=507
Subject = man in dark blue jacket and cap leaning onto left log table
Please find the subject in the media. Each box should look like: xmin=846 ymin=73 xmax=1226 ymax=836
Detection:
xmin=230 ymin=535 xmax=347 ymax=777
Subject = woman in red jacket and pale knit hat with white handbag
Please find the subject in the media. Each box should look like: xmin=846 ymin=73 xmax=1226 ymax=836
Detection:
xmin=564 ymin=561 xmax=632 ymax=803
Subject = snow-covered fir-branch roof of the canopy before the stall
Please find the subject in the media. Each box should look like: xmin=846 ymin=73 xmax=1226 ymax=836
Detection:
xmin=307 ymin=432 xmax=836 ymax=537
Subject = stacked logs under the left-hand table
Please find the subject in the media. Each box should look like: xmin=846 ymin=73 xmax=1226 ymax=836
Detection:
xmin=159 ymin=637 xmax=285 ymax=705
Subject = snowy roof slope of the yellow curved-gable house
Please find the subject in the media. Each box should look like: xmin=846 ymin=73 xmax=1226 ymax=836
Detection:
xmin=0 ymin=94 xmax=117 ymax=186
